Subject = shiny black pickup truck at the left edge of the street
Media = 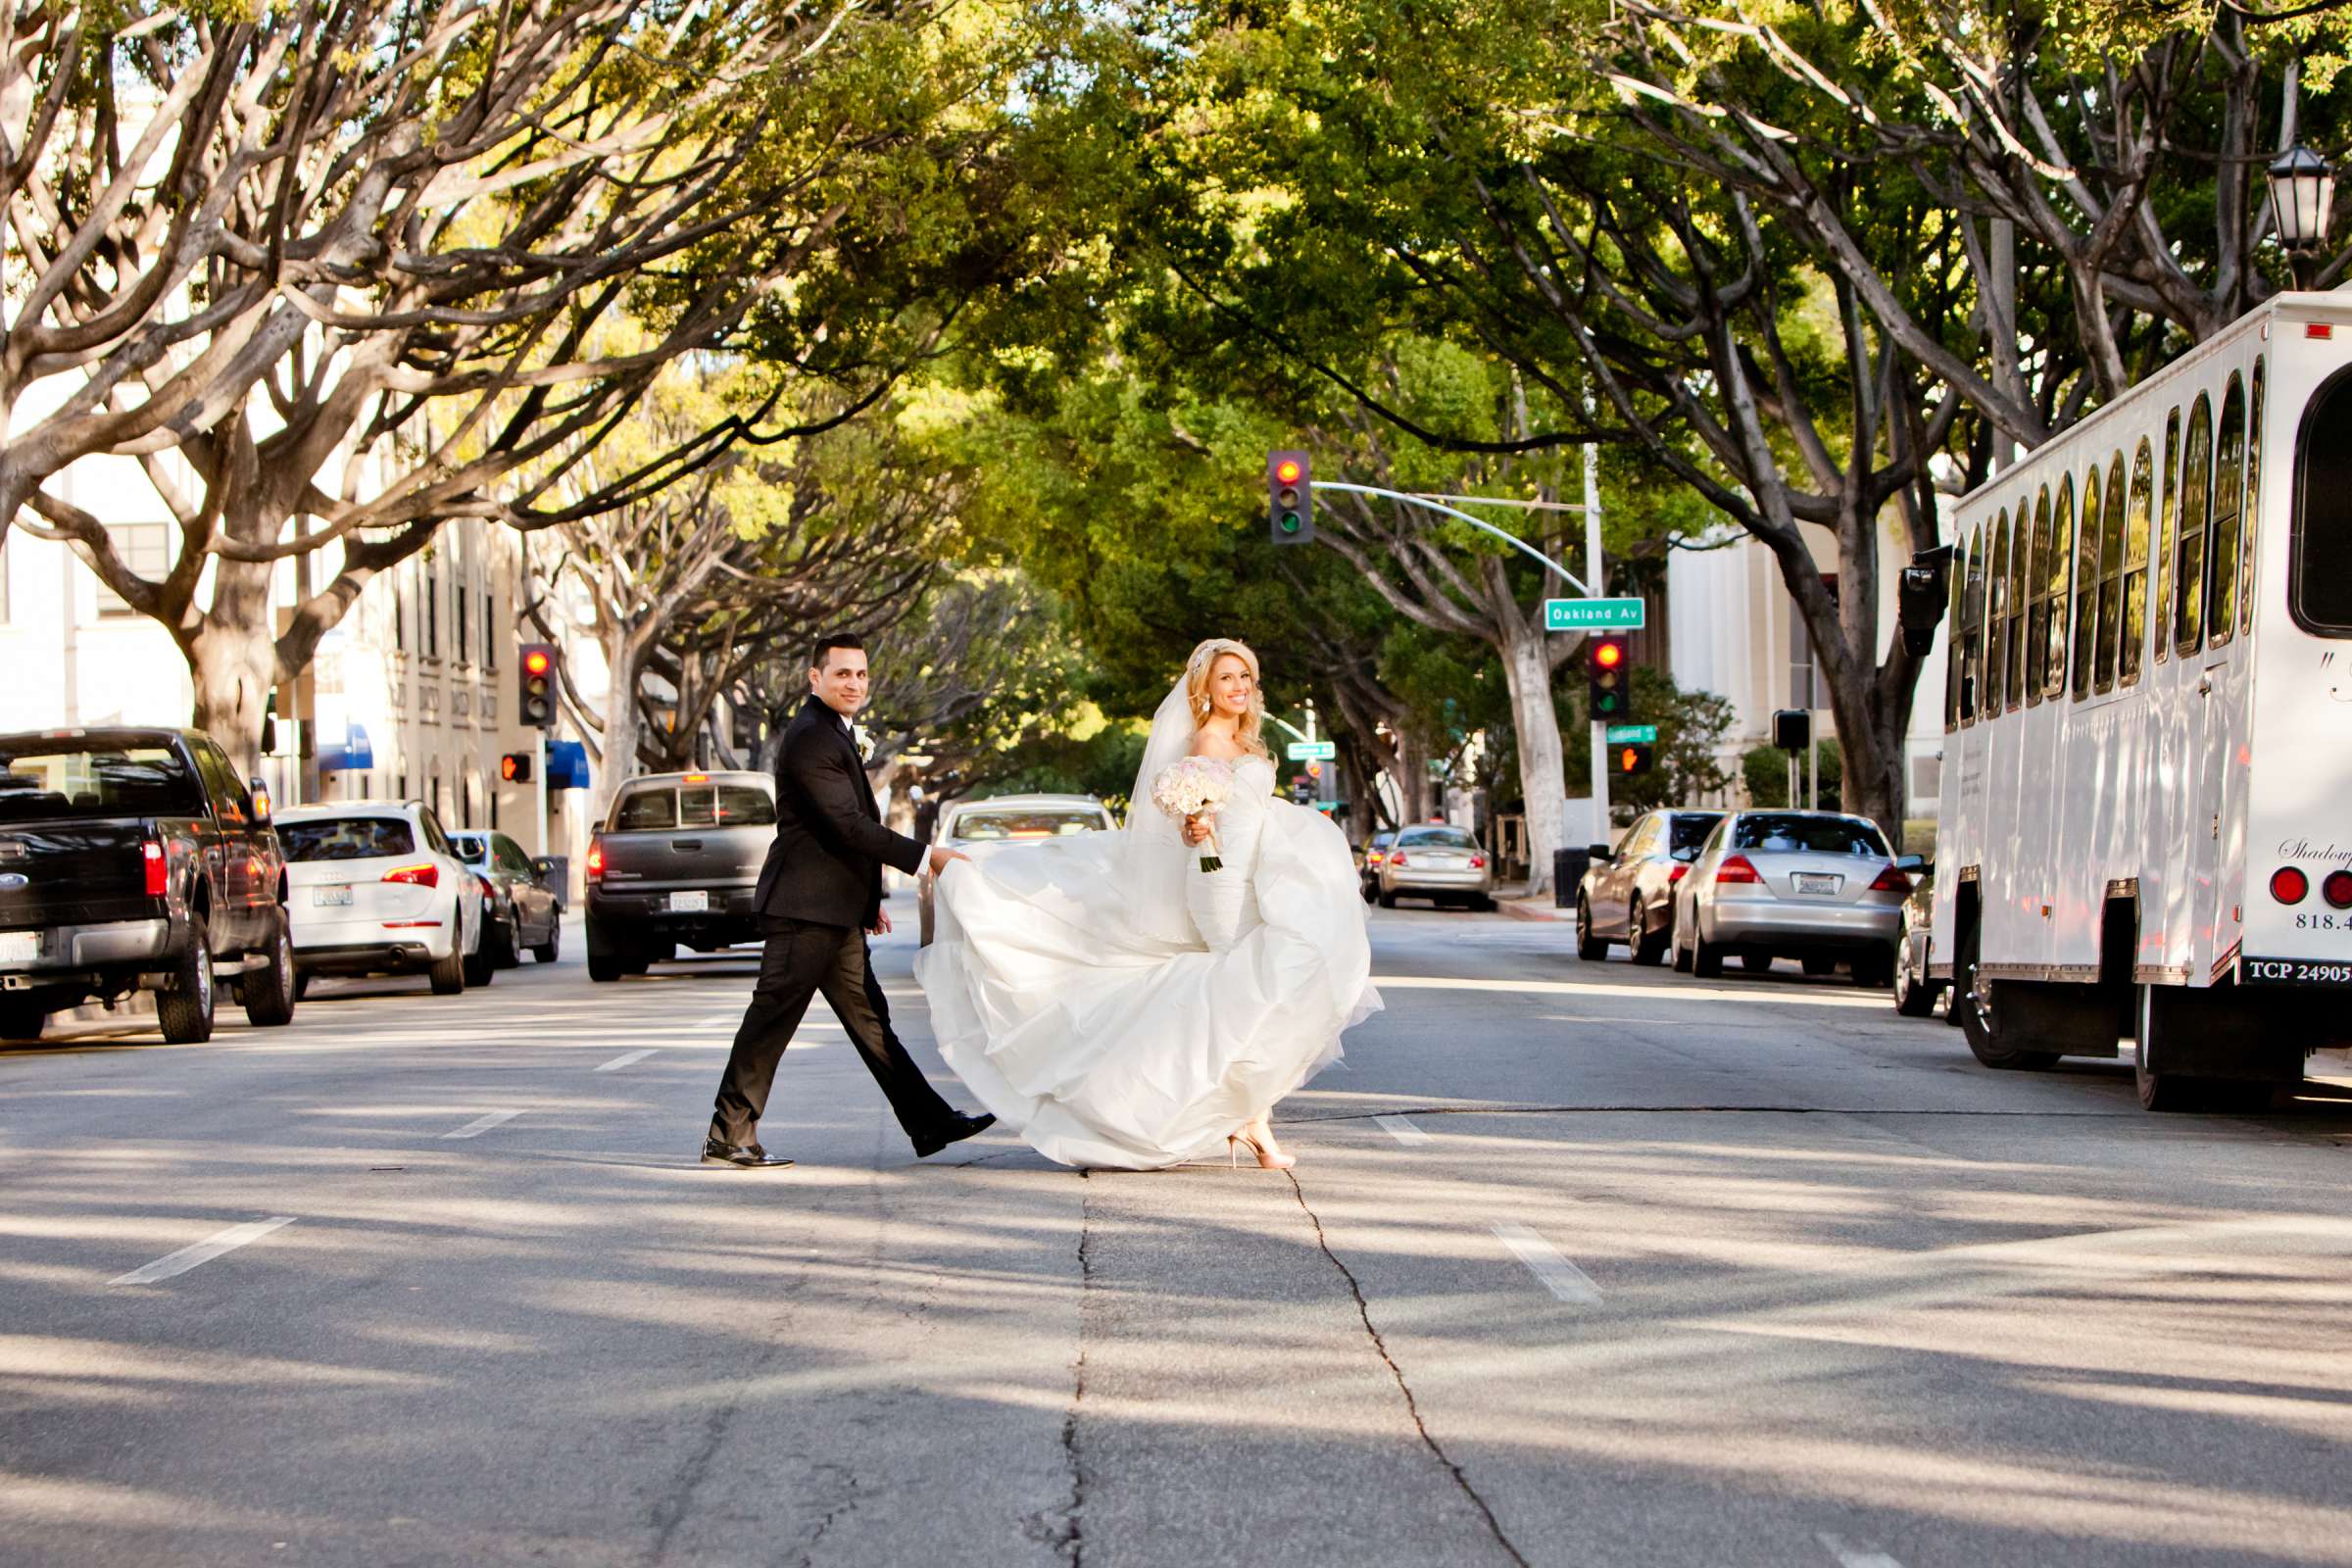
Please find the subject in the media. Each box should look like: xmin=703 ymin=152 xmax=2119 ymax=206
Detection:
xmin=0 ymin=729 xmax=294 ymax=1044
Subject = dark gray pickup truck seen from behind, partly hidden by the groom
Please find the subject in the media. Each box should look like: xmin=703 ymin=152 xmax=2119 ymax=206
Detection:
xmin=588 ymin=773 xmax=776 ymax=980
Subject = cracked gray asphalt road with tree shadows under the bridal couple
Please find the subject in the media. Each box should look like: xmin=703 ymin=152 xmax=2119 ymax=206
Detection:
xmin=0 ymin=909 xmax=2352 ymax=1568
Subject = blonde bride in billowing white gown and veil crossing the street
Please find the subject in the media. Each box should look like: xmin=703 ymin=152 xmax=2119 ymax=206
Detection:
xmin=915 ymin=637 xmax=1381 ymax=1171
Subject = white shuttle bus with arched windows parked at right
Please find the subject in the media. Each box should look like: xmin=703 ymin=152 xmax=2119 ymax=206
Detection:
xmin=1929 ymin=294 xmax=2352 ymax=1109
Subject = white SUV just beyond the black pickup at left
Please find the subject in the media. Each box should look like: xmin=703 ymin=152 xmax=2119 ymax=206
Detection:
xmin=277 ymin=800 xmax=496 ymax=997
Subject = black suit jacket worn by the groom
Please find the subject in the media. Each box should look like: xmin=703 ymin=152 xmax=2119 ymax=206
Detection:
xmin=758 ymin=696 xmax=924 ymax=931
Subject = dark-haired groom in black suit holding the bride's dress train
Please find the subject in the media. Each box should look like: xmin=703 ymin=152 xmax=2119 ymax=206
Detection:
xmin=704 ymin=635 xmax=995 ymax=1171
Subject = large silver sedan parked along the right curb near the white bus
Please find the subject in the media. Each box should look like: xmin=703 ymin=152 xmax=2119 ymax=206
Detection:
xmin=1675 ymin=811 xmax=1910 ymax=985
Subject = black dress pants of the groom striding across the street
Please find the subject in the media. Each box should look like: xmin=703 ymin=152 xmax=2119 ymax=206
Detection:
xmin=710 ymin=919 xmax=955 ymax=1145
